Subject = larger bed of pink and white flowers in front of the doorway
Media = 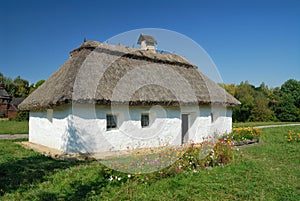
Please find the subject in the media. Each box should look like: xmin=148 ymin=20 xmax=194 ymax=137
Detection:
xmin=104 ymin=138 xmax=235 ymax=183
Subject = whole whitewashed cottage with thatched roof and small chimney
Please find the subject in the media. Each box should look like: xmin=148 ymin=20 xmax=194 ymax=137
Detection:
xmin=19 ymin=35 xmax=240 ymax=153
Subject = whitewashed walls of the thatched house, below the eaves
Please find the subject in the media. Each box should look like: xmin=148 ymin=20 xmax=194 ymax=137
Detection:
xmin=29 ymin=105 xmax=232 ymax=153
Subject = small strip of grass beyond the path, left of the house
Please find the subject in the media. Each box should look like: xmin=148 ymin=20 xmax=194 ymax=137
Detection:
xmin=0 ymin=121 xmax=28 ymax=134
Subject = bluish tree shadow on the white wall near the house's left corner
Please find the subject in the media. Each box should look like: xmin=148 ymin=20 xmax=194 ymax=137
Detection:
xmin=60 ymin=115 xmax=95 ymax=154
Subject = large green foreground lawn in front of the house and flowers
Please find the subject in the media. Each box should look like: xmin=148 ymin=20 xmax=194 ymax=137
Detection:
xmin=0 ymin=126 xmax=300 ymax=200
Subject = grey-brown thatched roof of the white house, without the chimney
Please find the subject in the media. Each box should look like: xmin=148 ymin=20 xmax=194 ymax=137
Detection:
xmin=19 ymin=41 xmax=240 ymax=110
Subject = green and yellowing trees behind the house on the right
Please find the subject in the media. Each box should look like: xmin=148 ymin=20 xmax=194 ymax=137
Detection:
xmin=221 ymin=79 xmax=300 ymax=122
